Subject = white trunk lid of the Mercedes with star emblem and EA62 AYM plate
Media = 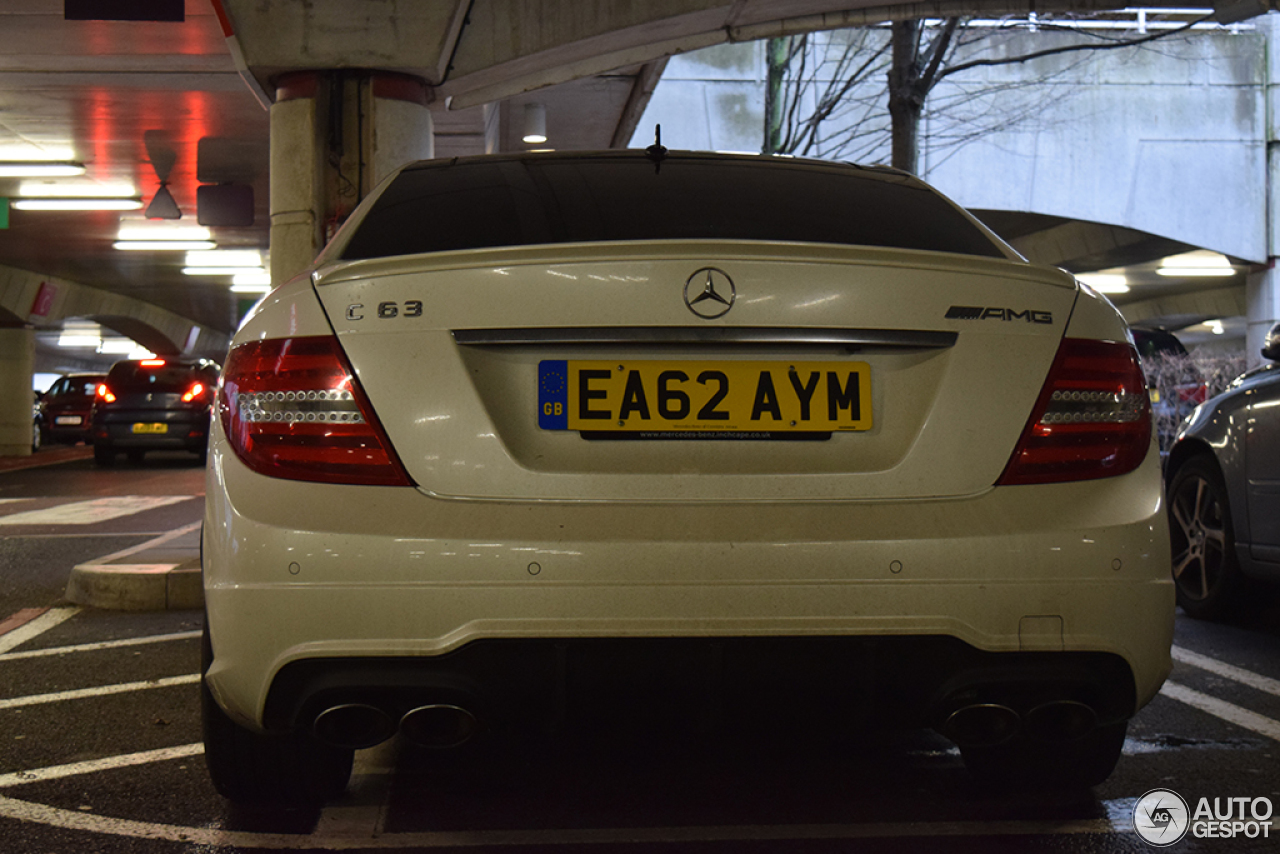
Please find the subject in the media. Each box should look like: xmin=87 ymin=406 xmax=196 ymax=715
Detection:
xmin=315 ymin=241 xmax=1076 ymax=501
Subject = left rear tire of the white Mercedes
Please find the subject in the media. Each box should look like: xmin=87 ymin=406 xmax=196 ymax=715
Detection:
xmin=200 ymin=621 xmax=355 ymax=807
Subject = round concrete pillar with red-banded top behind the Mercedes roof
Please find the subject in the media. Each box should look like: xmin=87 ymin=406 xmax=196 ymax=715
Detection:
xmin=271 ymin=70 xmax=435 ymax=284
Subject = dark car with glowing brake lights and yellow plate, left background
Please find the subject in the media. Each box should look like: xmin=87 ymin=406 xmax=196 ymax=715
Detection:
xmin=93 ymin=359 xmax=220 ymax=466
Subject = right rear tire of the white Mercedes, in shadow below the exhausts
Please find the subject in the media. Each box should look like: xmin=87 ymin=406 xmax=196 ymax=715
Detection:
xmin=960 ymin=721 xmax=1129 ymax=790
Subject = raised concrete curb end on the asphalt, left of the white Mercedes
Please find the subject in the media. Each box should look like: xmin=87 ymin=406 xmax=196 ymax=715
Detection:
xmin=67 ymin=522 xmax=205 ymax=611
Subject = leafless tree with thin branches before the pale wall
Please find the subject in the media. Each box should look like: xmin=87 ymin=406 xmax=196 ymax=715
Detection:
xmin=763 ymin=15 xmax=1208 ymax=173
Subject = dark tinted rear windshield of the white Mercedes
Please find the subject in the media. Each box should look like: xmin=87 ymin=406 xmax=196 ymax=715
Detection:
xmin=342 ymin=154 xmax=1005 ymax=260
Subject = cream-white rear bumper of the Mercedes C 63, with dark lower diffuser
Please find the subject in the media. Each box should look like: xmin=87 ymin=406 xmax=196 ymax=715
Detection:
xmin=204 ymin=439 xmax=1174 ymax=727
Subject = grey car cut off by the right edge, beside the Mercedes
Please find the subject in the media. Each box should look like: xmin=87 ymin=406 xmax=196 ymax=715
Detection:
xmin=1167 ymin=324 xmax=1280 ymax=618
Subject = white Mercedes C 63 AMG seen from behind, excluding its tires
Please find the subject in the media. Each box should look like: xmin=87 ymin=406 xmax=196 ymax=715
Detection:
xmin=205 ymin=152 xmax=1172 ymax=804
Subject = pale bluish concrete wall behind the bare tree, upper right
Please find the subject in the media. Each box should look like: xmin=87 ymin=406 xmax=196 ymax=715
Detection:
xmin=632 ymin=22 xmax=1276 ymax=262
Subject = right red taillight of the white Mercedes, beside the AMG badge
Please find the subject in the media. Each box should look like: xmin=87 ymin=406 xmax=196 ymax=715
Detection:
xmin=998 ymin=338 xmax=1151 ymax=485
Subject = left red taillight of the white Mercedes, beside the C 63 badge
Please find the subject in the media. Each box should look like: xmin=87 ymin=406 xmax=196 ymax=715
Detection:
xmin=219 ymin=337 xmax=412 ymax=487
